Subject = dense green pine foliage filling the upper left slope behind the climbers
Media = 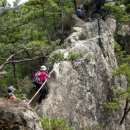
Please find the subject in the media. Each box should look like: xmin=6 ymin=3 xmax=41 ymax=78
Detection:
xmin=0 ymin=0 xmax=74 ymax=91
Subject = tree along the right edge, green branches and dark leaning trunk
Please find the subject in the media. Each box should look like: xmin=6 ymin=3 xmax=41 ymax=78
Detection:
xmin=105 ymin=44 xmax=130 ymax=125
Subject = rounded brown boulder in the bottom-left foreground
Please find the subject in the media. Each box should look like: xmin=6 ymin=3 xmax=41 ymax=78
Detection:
xmin=0 ymin=99 xmax=42 ymax=130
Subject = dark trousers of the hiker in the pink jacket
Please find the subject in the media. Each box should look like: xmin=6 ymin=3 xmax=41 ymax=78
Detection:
xmin=35 ymin=83 xmax=48 ymax=103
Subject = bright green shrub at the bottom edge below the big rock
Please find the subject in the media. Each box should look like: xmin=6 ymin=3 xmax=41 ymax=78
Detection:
xmin=41 ymin=118 xmax=72 ymax=130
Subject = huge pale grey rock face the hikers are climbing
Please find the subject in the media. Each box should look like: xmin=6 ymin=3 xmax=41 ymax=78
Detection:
xmin=37 ymin=17 xmax=126 ymax=130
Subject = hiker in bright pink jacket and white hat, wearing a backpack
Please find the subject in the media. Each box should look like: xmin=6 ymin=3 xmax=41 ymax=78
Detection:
xmin=33 ymin=65 xmax=50 ymax=104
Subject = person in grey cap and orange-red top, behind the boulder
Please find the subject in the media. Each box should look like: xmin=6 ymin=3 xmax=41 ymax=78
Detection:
xmin=6 ymin=86 xmax=17 ymax=100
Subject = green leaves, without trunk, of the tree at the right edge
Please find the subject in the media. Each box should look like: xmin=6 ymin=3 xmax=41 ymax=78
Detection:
xmin=104 ymin=43 xmax=130 ymax=110
